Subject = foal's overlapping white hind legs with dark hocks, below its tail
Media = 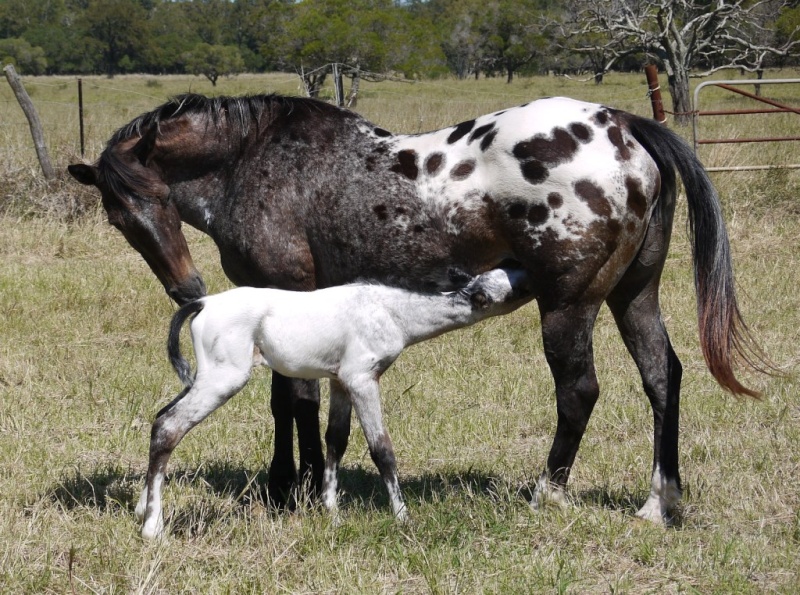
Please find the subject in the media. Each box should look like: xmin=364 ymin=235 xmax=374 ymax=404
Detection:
xmin=136 ymin=366 xmax=250 ymax=539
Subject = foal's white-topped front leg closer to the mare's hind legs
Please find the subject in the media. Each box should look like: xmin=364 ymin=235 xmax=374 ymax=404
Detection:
xmin=340 ymin=373 xmax=408 ymax=521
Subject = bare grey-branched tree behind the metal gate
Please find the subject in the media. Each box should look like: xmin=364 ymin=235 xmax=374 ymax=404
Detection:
xmin=562 ymin=0 xmax=800 ymax=124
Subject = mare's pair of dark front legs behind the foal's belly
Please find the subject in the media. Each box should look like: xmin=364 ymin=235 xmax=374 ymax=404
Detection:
xmin=267 ymin=372 xmax=325 ymax=508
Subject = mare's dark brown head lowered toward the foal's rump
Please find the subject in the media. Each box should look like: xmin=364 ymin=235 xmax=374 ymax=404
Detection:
xmin=68 ymin=99 xmax=206 ymax=304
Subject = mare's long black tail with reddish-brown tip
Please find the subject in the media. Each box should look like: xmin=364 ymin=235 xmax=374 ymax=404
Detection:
xmin=628 ymin=116 xmax=774 ymax=398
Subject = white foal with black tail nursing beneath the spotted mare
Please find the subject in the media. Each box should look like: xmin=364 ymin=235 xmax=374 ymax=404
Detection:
xmin=136 ymin=269 xmax=533 ymax=538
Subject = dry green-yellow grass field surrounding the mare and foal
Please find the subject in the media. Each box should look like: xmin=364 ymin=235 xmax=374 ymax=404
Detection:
xmin=0 ymin=72 xmax=800 ymax=593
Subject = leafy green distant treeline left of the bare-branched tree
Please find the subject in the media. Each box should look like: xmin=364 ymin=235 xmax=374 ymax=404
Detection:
xmin=0 ymin=0 xmax=625 ymax=80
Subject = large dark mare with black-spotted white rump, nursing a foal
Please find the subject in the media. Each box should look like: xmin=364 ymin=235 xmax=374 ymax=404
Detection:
xmin=69 ymin=94 xmax=763 ymax=522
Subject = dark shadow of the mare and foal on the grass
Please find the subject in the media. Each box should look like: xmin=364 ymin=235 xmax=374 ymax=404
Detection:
xmin=47 ymin=461 xmax=684 ymax=534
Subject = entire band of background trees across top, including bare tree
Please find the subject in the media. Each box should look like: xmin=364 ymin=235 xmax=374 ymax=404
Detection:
xmin=0 ymin=0 xmax=800 ymax=87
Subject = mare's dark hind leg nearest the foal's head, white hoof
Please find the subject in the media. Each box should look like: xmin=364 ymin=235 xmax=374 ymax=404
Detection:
xmin=531 ymin=304 xmax=600 ymax=508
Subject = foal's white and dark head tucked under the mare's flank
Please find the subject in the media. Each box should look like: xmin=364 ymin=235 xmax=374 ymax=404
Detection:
xmin=461 ymin=268 xmax=534 ymax=316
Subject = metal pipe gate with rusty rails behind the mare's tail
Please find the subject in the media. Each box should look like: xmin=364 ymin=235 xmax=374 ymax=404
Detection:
xmin=692 ymin=79 xmax=800 ymax=171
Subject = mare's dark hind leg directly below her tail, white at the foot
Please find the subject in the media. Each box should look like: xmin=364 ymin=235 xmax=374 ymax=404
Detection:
xmin=607 ymin=239 xmax=682 ymax=523
